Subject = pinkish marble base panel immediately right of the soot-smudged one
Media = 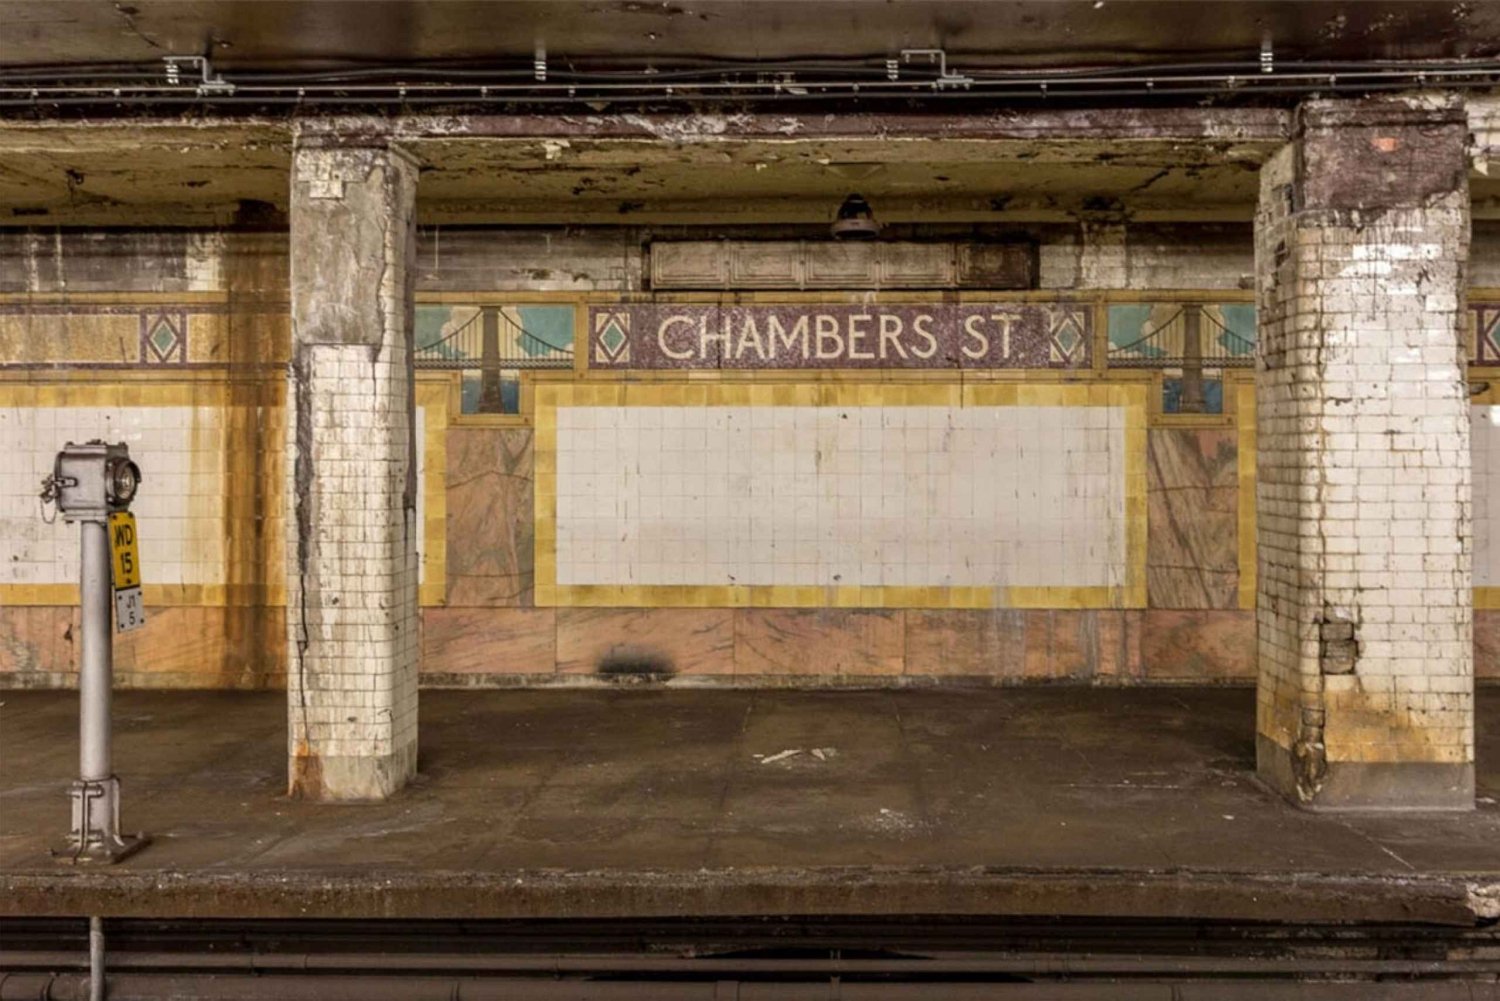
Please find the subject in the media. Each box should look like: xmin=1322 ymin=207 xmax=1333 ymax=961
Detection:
xmin=735 ymin=608 xmax=909 ymax=677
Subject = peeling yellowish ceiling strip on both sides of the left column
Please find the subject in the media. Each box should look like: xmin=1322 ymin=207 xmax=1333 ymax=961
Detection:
xmin=0 ymin=123 xmax=1277 ymax=225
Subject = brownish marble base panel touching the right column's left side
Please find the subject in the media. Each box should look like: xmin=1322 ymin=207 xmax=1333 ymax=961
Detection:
xmin=1140 ymin=609 xmax=1256 ymax=681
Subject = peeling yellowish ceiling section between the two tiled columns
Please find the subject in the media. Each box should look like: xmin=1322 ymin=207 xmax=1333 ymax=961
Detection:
xmin=419 ymin=140 xmax=1268 ymax=222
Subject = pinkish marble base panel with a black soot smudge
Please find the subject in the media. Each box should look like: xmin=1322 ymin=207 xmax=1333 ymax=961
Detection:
xmin=557 ymin=608 xmax=735 ymax=678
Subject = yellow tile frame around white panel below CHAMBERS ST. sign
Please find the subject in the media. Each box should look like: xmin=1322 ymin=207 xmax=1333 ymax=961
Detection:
xmin=533 ymin=381 xmax=1149 ymax=609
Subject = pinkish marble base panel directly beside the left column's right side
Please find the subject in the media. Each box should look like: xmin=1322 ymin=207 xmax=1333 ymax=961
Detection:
xmin=422 ymin=608 xmax=557 ymax=675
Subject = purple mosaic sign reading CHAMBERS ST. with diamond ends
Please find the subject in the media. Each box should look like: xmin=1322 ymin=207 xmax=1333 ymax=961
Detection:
xmin=588 ymin=303 xmax=1094 ymax=369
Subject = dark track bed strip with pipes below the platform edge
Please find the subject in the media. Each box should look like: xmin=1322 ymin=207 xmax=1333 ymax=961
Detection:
xmin=0 ymin=917 xmax=1500 ymax=1001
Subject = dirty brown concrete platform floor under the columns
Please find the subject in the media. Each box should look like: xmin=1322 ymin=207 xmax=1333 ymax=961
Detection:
xmin=0 ymin=687 xmax=1500 ymax=923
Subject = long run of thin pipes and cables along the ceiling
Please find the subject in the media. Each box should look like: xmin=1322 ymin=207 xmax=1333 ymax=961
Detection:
xmin=0 ymin=57 xmax=1500 ymax=114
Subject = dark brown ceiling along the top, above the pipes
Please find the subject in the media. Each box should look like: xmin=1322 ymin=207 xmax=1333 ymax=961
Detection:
xmin=0 ymin=0 xmax=1500 ymax=69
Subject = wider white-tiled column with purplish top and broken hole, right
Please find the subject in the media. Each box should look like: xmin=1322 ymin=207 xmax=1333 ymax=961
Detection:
xmin=1256 ymin=99 xmax=1475 ymax=809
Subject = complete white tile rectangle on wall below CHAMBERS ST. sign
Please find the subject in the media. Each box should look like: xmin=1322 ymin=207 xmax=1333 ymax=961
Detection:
xmin=557 ymin=407 xmax=1127 ymax=587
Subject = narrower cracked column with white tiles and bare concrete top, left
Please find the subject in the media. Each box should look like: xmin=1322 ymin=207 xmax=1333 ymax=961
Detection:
xmin=287 ymin=138 xmax=419 ymax=800
